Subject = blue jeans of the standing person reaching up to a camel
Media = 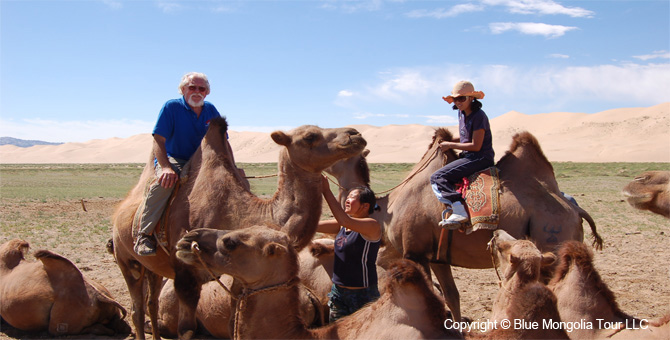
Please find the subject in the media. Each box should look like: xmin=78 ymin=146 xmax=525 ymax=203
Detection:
xmin=328 ymin=284 xmax=379 ymax=322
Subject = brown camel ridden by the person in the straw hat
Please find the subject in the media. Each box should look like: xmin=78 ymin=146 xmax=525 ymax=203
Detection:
xmin=330 ymin=129 xmax=602 ymax=321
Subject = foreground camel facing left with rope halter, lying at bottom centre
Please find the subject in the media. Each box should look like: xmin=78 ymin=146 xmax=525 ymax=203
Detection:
xmin=177 ymin=226 xmax=460 ymax=339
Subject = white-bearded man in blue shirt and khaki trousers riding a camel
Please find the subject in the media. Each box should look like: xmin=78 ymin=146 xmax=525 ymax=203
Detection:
xmin=135 ymin=72 xmax=244 ymax=256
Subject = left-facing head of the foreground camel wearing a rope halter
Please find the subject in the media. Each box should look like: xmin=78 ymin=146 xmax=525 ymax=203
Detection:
xmin=177 ymin=226 xmax=298 ymax=288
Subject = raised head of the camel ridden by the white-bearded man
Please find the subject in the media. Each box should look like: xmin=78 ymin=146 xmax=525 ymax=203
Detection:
xmin=271 ymin=125 xmax=367 ymax=173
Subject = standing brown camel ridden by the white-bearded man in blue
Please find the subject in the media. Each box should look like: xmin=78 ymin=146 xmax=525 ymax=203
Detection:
xmin=113 ymin=118 xmax=366 ymax=339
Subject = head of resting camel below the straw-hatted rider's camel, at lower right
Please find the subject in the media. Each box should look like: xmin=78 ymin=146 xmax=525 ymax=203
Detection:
xmin=489 ymin=229 xmax=556 ymax=282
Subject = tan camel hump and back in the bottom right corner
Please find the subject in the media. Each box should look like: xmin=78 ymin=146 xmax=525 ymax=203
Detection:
xmin=548 ymin=241 xmax=670 ymax=339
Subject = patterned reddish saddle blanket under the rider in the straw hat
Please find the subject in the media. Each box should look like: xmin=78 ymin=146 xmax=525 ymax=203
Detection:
xmin=459 ymin=166 xmax=500 ymax=234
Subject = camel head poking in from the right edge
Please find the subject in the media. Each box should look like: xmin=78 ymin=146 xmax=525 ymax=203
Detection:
xmin=623 ymin=171 xmax=670 ymax=218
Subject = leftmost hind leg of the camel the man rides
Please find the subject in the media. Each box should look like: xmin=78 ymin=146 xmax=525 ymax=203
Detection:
xmin=116 ymin=258 xmax=146 ymax=340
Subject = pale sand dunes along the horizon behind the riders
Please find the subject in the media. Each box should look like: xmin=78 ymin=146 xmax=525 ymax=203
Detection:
xmin=0 ymin=103 xmax=670 ymax=164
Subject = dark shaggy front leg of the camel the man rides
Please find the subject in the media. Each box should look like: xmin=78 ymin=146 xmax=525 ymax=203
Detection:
xmin=174 ymin=266 xmax=202 ymax=339
